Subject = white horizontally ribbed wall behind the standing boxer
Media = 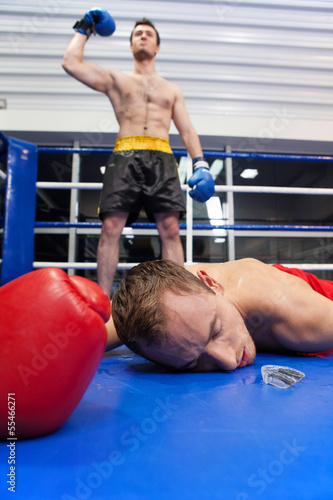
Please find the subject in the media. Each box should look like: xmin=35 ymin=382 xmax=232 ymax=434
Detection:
xmin=0 ymin=0 xmax=333 ymax=145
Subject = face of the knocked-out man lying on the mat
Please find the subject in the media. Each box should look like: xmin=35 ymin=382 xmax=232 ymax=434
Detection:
xmin=143 ymin=292 xmax=256 ymax=371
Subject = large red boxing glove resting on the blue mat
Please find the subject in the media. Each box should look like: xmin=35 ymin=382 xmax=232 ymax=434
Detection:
xmin=0 ymin=268 xmax=110 ymax=438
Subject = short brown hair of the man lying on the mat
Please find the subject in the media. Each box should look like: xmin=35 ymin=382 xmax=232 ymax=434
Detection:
xmin=112 ymin=260 xmax=214 ymax=357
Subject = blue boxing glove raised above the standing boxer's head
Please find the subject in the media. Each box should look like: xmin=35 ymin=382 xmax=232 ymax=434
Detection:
xmin=73 ymin=7 xmax=116 ymax=38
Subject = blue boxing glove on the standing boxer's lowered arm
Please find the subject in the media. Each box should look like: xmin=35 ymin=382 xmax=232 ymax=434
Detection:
xmin=188 ymin=157 xmax=215 ymax=203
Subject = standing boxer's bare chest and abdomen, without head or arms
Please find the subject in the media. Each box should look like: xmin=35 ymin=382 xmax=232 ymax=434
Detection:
xmin=107 ymin=70 xmax=178 ymax=140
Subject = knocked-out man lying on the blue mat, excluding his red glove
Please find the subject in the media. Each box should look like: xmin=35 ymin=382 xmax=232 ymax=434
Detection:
xmin=109 ymin=259 xmax=333 ymax=371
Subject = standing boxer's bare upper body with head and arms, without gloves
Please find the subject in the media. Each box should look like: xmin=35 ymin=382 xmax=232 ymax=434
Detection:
xmin=62 ymin=30 xmax=202 ymax=158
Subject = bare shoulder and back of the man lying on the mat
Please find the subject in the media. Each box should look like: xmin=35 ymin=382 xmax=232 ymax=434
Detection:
xmin=187 ymin=259 xmax=333 ymax=352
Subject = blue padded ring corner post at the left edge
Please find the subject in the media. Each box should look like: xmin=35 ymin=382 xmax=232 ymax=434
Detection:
xmin=0 ymin=138 xmax=38 ymax=285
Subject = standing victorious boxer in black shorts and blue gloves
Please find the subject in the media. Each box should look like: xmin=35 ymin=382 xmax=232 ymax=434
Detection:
xmin=63 ymin=8 xmax=214 ymax=296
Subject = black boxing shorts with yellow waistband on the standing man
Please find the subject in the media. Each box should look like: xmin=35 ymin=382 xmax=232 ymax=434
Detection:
xmin=98 ymin=136 xmax=186 ymax=225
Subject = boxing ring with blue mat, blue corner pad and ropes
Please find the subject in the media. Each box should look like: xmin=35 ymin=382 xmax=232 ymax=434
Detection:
xmin=0 ymin=131 xmax=333 ymax=500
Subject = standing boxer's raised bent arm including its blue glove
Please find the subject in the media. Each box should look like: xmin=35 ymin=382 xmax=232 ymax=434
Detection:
xmin=62 ymin=8 xmax=115 ymax=93
